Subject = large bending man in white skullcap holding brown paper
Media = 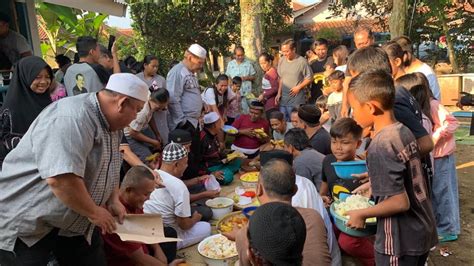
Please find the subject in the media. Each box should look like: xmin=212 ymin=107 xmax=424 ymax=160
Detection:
xmin=0 ymin=73 xmax=149 ymax=265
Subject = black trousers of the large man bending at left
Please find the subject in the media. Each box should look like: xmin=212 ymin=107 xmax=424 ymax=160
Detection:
xmin=0 ymin=229 xmax=107 ymax=266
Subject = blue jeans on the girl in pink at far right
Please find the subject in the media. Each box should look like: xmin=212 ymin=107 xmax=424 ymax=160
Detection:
xmin=432 ymin=154 xmax=461 ymax=235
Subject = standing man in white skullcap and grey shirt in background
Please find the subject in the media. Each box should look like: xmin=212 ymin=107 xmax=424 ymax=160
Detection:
xmin=166 ymin=43 xmax=207 ymax=156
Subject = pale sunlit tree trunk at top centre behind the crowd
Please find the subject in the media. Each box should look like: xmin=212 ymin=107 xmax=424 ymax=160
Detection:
xmin=240 ymin=0 xmax=263 ymax=95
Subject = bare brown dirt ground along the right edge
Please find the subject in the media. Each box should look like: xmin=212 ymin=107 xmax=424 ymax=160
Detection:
xmin=429 ymin=142 xmax=474 ymax=265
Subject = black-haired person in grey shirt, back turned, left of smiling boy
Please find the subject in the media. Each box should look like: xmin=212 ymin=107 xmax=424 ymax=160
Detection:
xmin=285 ymin=128 xmax=324 ymax=191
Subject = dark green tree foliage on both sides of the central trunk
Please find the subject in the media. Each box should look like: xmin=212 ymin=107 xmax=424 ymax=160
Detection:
xmin=129 ymin=0 xmax=291 ymax=74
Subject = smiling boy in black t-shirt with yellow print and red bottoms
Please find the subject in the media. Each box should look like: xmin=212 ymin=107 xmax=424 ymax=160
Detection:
xmin=319 ymin=118 xmax=375 ymax=266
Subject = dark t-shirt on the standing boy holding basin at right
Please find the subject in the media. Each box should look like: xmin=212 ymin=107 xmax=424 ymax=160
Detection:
xmin=367 ymin=123 xmax=437 ymax=256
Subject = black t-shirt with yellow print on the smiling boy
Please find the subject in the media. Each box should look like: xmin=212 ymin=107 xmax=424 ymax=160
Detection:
xmin=321 ymin=154 xmax=362 ymax=199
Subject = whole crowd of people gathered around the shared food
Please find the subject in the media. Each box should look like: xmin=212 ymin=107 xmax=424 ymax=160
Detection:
xmin=0 ymin=20 xmax=461 ymax=265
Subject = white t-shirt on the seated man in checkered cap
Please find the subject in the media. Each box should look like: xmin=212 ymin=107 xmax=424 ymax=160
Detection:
xmin=143 ymin=170 xmax=191 ymax=229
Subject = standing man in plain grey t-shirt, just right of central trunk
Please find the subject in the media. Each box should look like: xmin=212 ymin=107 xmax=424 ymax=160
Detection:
xmin=275 ymin=39 xmax=313 ymax=121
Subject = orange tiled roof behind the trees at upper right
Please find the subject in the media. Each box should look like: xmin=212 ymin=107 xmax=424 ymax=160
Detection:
xmin=302 ymin=19 xmax=388 ymax=35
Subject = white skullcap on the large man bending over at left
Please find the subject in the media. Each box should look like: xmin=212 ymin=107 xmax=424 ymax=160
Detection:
xmin=105 ymin=73 xmax=150 ymax=102
